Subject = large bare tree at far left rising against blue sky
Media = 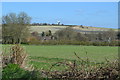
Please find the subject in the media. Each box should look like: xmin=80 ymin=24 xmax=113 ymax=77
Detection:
xmin=2 ymin=12 xmax=31 ymax=43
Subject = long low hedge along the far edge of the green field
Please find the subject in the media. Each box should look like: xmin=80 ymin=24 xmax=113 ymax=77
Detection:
xmin=28 ymin=40 xmax=120 ymax=46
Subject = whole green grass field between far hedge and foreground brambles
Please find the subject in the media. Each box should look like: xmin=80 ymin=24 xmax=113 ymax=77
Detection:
xmin=3 ymin=45 xmax=118 ymax=69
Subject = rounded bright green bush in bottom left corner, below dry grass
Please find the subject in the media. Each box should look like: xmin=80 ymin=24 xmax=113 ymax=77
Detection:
xmin=2 ymin=64 xmax=30 ymax=80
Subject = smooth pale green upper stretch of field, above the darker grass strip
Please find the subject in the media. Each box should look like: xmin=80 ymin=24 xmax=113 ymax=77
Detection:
xmin=25 ymin=45 xmax=118 ymax=61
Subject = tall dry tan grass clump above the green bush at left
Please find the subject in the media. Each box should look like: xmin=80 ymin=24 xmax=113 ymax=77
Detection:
xmin=2 ymin=44 xmax=33 ymax=70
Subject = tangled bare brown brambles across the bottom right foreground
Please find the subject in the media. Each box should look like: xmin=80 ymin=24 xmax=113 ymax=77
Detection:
xmin=44 ymin=53 xmax=120 ymax=80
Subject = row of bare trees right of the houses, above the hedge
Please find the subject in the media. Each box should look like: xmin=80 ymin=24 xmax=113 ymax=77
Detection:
xmin=55 ymin=27 xmax=120 ymax=42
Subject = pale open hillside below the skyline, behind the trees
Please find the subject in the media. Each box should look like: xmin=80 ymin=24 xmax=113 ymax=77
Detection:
xmin=30 ymin=26 xmax=118 ymax=33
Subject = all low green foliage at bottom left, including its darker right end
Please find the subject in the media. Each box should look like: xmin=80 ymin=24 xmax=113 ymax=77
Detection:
xmin=2 ymin=64 xmax=42 ymax=80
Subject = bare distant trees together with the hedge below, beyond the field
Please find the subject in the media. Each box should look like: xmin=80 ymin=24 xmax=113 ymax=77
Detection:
xmin=28 ymin=27 xmax=120 ymax=46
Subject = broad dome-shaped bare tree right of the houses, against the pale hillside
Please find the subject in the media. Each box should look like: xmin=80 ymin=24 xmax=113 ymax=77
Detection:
xmin=55 ymin=27 xmax=87 ymax=41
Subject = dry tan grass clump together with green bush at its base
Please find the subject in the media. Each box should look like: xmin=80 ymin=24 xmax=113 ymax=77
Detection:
xmin=2 ymin=45 xmax=41 ymax=80
